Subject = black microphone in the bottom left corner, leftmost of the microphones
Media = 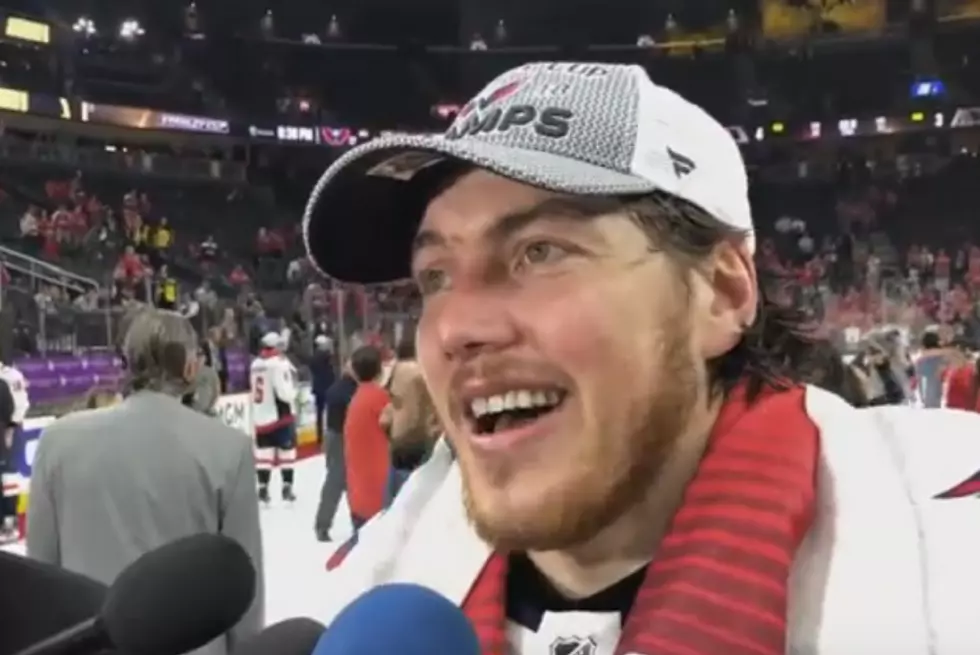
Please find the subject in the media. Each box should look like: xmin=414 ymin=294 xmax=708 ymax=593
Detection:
xmin=0 ymin=552 xmax=108 ymax=655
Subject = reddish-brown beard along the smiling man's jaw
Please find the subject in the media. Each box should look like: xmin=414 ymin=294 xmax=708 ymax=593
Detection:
xmin=460 ymin=315 xmax=703 ymax=551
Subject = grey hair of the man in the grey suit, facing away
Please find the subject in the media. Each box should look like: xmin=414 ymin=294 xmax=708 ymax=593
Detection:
xmin=122 ymin=309 xmax=198 ymax=397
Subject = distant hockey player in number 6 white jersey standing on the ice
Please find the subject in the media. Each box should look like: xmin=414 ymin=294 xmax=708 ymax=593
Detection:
xmin=249 ymin=332 xmax=296 ymax=503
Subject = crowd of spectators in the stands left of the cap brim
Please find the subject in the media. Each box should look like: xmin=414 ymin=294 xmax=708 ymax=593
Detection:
xmin=0 ymin=161 xmax=424 ymax=372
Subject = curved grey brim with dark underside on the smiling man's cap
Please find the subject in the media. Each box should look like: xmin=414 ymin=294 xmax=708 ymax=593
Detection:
xmin=303 ymin=135 xmax=656 ymax=284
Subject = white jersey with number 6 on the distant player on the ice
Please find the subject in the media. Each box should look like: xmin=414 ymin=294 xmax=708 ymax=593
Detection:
xmin=249 ymin=348 xmax=296 ymax=434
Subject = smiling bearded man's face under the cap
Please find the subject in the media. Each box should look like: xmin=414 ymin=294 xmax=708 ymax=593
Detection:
xmin=413 ymin=171 xmax=730 ymax=550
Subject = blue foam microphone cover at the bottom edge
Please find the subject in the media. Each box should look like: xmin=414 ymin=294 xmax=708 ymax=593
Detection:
xmin=313 ymin=584 xmax=480 ymax=655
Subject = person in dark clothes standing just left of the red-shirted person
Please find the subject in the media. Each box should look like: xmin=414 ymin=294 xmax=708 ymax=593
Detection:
xmin=314 ymin=362 xmax=357 ymax=541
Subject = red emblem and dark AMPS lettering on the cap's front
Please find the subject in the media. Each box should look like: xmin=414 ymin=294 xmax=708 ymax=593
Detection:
xmin=445 ymin=73 xmax=574 ymax=141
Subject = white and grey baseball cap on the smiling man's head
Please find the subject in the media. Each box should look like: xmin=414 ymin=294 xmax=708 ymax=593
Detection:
xmin=303 ymin=62 xmax=754 ymax=284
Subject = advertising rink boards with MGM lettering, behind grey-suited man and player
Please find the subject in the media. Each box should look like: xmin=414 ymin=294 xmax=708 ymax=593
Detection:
xmin=3 ymin=385 xmax=316 ymax=513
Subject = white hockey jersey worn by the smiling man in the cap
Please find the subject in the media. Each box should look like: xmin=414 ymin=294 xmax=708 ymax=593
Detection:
xmin=309 ymin=388 xmax=980 ymax=655
